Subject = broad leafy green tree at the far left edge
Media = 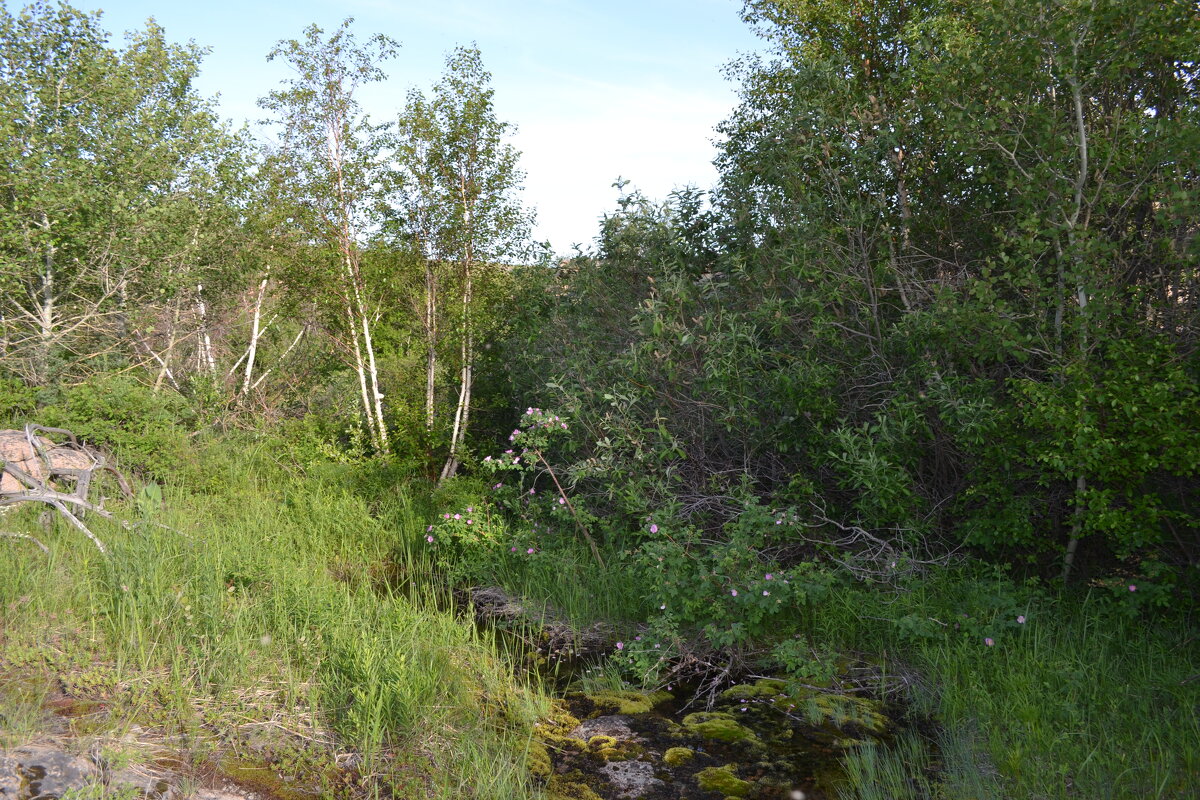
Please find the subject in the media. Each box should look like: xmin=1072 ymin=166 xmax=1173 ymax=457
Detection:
xmin=0 ymin=2 xmax=244 ymax=385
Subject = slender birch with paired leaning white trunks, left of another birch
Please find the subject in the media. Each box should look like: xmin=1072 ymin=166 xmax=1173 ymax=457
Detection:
xmin=259 ymin=19 xmax=398 ymax=453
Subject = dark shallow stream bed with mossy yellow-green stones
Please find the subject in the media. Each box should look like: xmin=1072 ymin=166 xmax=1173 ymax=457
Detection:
xmin=468 ymin=589 xmax=896 ymax=800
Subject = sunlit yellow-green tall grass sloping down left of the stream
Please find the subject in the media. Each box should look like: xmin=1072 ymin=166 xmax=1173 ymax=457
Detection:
xmin=0 ymin=443 xmax=542 ymax=798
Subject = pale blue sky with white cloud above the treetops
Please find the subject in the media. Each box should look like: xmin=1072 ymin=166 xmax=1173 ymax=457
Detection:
xmin=49 ymin=0 xmax=764 ymax=254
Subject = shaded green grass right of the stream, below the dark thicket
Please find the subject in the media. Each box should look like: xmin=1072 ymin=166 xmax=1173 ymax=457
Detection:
xmin=826 ymin=577 xmax=1200 ymax=800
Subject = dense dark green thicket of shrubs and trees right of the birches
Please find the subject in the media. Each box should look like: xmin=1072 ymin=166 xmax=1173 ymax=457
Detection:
xmin=508 ymin=1 xmax=1200 ymax=604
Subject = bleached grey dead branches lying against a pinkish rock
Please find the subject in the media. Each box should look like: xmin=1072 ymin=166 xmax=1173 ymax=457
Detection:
xmin=0 ymin=423 xmax=133 ymax=553
